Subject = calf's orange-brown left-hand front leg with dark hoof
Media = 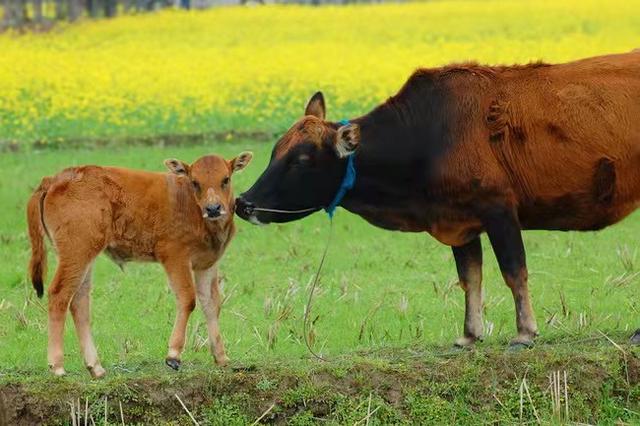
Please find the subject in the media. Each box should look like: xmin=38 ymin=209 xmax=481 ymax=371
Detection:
xmin=163 ymin=259 xmax=196 ymax=370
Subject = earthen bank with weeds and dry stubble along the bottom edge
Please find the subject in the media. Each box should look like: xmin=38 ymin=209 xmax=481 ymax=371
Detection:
xmin=0 ymin=342 xmax=640 ymax=425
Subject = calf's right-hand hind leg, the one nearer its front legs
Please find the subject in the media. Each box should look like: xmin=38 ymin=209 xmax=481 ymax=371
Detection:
xmin=70 ymin=266 xmax=106 ymax=378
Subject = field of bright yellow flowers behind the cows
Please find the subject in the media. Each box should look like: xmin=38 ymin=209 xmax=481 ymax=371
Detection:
xmin=0 ymin=0 xmax=640 ymax=144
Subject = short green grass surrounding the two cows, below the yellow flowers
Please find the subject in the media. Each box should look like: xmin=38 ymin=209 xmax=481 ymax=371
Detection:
xmin=0 ymin=141 xmax=640 ymax=424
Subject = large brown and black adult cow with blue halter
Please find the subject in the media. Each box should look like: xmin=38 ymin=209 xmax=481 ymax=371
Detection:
xmin=236 ymin=51 xmax=640 ymax=347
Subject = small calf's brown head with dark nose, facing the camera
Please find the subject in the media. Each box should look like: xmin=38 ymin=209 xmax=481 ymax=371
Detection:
xmin=164 ymin=152 xmax=253 ymax=221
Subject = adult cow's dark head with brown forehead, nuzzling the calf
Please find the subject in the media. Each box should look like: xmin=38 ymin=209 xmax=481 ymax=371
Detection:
xmin=236 ymin=92 xmax=360 ymax=224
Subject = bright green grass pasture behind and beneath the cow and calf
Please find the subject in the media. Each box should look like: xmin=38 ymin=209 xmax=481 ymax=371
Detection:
xmin=0 ymin=141 xmax=640 ymax=424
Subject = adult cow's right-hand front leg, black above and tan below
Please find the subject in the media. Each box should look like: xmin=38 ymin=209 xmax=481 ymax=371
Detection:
xmin=484 ymin=208 xmax=538 ymax=347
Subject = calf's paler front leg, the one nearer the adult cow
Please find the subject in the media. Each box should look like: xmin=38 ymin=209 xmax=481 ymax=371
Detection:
xmin=194 ymin=266 xmax=229 ymax=366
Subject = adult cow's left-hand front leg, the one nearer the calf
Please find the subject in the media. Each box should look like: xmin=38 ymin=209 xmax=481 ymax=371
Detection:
xmin=452 ymin=236 xmax=482 ymax=347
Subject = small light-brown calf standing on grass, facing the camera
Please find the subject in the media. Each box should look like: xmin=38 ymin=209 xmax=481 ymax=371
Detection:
xmin=27 ymin=152 xmax=252 ymax=377
